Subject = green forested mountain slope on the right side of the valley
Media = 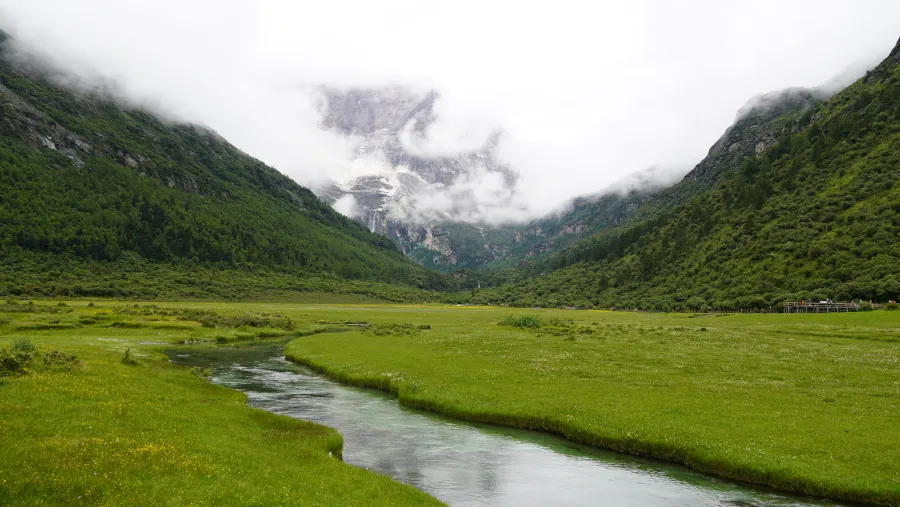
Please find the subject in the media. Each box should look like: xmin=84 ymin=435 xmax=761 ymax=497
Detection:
xmin=473 ymin=36 xmax=900 ymax=309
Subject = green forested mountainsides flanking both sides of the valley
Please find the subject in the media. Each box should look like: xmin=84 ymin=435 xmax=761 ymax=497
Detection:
xmin=0 ymin=27 xmax=900 ymax=310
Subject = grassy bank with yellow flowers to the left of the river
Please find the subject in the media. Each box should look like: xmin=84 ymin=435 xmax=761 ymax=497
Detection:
xmin=0 ymin=302 xmax=437 ymax=505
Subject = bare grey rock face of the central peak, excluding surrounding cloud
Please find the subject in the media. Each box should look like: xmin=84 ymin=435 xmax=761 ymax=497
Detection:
xmin=319 ymin=87 xmax=516 ymax=263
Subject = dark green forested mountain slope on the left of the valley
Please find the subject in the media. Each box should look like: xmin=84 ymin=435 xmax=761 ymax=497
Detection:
xmin=0 ymin=31 xmax=445 ymax=295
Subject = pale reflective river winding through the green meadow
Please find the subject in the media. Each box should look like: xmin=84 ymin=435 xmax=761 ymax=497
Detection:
xmin=169 ymin=345 xmax=836 ymax=506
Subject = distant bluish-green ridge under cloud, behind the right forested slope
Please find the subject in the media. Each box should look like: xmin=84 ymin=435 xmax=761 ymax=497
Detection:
xmin=408 ymin=88 xmax=830 ymax=279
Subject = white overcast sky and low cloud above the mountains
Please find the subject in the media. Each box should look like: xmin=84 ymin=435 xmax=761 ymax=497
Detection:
xmin=0 ymin=0 xmax=900 ymax=221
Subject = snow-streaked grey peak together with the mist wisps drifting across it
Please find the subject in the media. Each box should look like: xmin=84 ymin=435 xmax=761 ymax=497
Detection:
xmin=320 ymin=87 xmax=517 ymax=231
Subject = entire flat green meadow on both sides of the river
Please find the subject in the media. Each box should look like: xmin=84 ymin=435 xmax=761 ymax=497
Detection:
xmin=0 ymin=301 xmax=900 ymax=505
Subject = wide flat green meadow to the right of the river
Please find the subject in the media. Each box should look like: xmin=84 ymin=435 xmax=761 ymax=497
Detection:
xmin=287 ymin=307 xmax=900 ymax=505
